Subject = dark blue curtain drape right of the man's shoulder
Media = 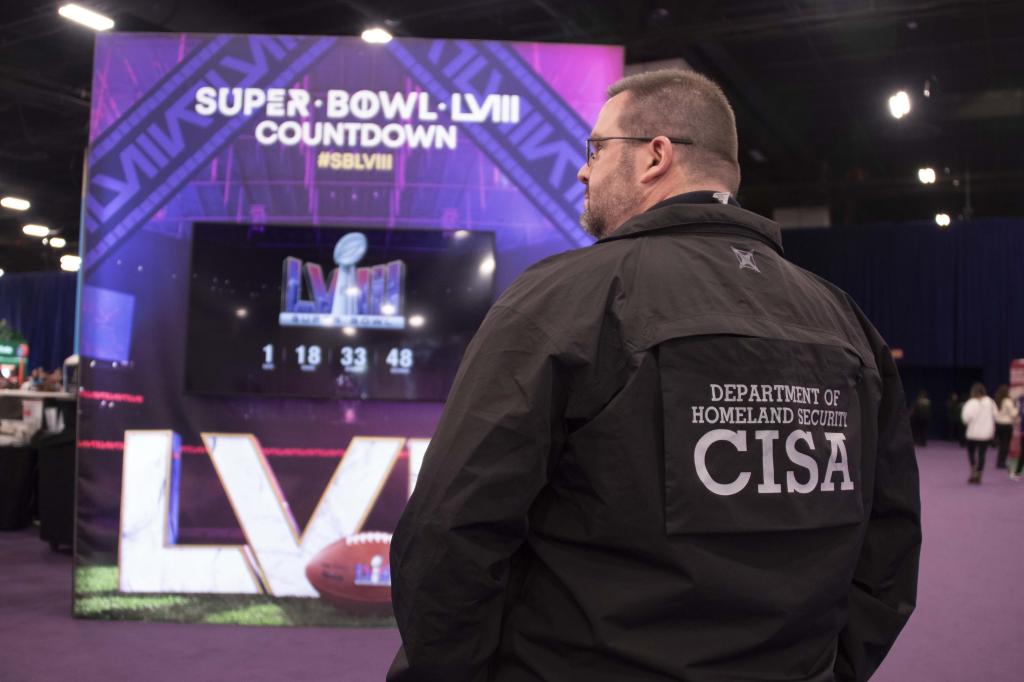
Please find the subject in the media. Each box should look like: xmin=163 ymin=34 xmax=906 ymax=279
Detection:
xmin=782 ymin=219 xmax=1024 ymax=391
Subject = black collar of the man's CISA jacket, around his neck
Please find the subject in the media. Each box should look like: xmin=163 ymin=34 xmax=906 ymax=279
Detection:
xmin=597 ymin=202 xmax=782 ymax=254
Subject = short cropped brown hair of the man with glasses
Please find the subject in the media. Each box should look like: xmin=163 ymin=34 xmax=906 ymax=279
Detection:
xmin=608 ymin=69 xmax=739 ymax=191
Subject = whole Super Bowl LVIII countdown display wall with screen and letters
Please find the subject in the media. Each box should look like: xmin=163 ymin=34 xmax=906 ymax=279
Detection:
xmin=75 ymin=34 xmax=623 ymax=625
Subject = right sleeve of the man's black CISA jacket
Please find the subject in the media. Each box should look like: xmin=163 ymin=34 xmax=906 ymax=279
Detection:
xmin=835 ymin=330 xmax=921 ymax=682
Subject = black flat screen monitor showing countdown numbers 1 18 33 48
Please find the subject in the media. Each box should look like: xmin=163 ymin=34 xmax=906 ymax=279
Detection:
xmin=185 ymin=222 xmax=495 ymax=400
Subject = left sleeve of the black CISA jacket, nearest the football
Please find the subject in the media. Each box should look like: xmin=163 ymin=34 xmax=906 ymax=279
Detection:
xmin=387 ymin=306 xmax=564 ymax=682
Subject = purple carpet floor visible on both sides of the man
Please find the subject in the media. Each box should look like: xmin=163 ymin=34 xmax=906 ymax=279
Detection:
xmin=0 ymin=443 xmax=1024 ymax=682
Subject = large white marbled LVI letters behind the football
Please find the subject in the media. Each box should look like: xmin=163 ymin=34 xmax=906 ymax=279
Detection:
xmin=119 ymin=431 xmax=429 ymax=597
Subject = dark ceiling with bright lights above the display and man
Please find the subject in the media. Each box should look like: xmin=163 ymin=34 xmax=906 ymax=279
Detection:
xmin=0 ymin=0 xmax=1024 ymax=271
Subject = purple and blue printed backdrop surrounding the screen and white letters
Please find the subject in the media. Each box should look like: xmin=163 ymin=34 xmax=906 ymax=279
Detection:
xmin=76 ymin=34 xmax=623 ymax=622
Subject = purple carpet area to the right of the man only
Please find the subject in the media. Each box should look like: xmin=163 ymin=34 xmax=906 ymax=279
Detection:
xmin=871 ymin=442 xmax=1024 ymax=682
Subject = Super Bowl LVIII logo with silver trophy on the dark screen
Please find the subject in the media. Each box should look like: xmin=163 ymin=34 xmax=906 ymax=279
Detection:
xmin=279 ymin=232 xmax=406 ymax=330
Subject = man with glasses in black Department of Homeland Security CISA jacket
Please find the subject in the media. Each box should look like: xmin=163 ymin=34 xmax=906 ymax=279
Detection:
xmin=389 ymin=71 xmax=921 ymax=682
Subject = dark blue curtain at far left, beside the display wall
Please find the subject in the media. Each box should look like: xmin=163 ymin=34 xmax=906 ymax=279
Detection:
xmin=0 ymin=272 xmax=78 ymax=371
